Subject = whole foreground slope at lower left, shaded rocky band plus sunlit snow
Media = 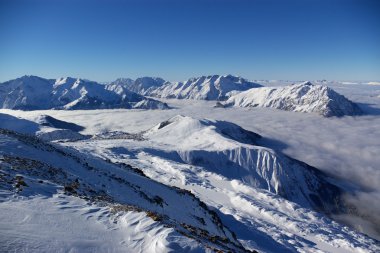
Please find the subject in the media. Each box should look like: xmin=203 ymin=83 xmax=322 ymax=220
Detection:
xmin=0 ymin=120 xmax=249 ymax=252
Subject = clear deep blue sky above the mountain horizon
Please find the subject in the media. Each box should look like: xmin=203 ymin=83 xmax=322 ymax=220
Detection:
xmin=0 ymin=0 xmax=380 ymax=81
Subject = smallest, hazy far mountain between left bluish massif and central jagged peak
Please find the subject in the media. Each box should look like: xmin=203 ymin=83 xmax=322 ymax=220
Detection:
xmin=108 ymin=77 xmax=168 ymax=95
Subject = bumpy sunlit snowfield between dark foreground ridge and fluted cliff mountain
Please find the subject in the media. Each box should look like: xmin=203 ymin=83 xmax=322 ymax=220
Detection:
xmin=134 ymin=153 xmax=380 ymax=253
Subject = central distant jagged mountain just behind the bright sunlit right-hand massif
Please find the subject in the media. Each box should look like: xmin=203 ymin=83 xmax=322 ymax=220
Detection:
xmin=147 ymin=75 xmax=261 ymax=100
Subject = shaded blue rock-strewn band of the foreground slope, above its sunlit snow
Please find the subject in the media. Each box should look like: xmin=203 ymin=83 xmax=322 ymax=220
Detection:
xmin=0 ymin=129 xmax=252 ymax=252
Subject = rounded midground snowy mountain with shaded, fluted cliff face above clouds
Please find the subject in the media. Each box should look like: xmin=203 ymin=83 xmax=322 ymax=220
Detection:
xmin=143 ymin=115 xmax=343 ymax=212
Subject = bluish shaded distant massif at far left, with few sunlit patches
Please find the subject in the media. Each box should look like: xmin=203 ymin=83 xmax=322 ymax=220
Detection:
xmin=0 ymin=76 xmax=168 ymax=110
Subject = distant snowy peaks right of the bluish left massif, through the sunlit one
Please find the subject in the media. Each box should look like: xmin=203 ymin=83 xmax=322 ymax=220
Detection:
xmin=112 ymin=75 xmax=362 ymax=117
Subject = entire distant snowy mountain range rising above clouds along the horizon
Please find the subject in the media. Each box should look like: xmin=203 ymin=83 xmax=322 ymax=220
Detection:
xmin=0 ymin=75 xmax=362 ymax=117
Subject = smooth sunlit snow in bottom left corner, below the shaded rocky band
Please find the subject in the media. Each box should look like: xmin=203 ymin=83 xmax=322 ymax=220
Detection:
xmin=0 ymin=191 xmax=199 ymax=253
